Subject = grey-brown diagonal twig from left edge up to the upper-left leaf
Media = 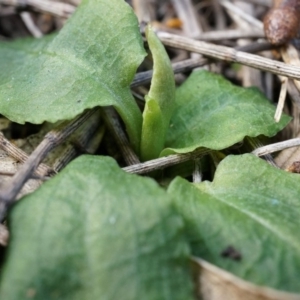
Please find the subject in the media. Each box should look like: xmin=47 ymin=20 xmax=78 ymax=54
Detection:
xmin=0 ymin=109 xmax=97 ymax=221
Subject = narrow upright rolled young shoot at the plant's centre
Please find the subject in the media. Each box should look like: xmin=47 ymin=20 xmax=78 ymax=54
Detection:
xmin=141 ymin=26 xmax=175 ymax=161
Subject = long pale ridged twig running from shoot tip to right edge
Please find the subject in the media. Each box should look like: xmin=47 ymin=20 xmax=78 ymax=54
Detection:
xmin=157 ymin=31 xmax=300 ymax=80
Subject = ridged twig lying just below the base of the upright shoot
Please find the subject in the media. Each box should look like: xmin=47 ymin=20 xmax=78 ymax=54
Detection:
xmin=123 ymin=148 xmax=211 ymax=174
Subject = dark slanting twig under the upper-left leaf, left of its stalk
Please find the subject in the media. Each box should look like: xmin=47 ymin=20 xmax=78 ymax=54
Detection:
xmin=102 ymin=107 xmax=140 ymax=165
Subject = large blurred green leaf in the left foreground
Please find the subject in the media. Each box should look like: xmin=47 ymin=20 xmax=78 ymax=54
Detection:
xmin=0 ymin=156 xmax=192 ymax=300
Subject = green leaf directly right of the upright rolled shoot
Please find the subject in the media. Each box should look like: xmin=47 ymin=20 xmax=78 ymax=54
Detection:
xmin=161 ymin=70 xmax=290 ymax=156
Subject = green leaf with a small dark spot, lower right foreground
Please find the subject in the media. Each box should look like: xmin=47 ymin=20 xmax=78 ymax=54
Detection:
xmin=169 ymin=154 xmax=300 ymax=292
